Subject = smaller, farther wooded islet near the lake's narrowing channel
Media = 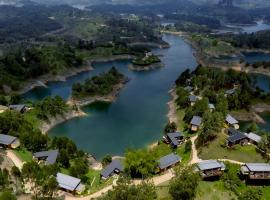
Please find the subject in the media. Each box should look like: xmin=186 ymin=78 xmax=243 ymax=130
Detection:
xmin=129 ymin=52 xmax=163 ymax=71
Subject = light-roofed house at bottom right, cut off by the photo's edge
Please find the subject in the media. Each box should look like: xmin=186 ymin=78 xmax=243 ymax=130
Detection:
xmin=240 ymin=163 xmax=270 ymax=180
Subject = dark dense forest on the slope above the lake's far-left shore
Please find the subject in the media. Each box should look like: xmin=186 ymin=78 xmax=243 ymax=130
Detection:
xmin=0 ymin=44 xmax=82 ymax=93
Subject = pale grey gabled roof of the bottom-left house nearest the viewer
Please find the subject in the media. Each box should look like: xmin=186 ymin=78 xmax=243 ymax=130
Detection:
xmin=56 ymin=173 xmax=81 ymax=191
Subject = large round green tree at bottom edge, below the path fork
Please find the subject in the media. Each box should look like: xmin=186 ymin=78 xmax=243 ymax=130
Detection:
xmin=169 ymin=167 xmax=200 ymax=200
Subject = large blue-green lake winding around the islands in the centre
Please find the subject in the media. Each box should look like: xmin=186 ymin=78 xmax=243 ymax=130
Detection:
xmin=26 ymin=35 xmax=197 ymax=159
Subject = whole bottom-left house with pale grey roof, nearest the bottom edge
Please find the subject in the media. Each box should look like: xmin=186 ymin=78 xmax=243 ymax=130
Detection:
xmin=56 ymin=173 xmax=85 ymax=193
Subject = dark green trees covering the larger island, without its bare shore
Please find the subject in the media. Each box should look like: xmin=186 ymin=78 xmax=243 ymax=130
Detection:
xmin=72 ymin=67 xmax=124 ymax=98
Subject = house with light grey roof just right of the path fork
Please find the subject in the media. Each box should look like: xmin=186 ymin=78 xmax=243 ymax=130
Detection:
xmin=197 ymin=160 xmax=226 ymax=178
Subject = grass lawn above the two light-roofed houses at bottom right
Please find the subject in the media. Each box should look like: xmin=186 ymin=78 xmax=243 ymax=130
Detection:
xmin=199 ymin=133 xmax=266 ymax=163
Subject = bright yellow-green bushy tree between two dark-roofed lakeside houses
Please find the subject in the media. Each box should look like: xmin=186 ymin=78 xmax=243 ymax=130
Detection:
xmin=125 ymin=150 xmax=157 ymax=179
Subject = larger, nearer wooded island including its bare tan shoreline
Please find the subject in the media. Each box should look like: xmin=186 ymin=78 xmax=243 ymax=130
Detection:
xmin=71 ymin=67 xmax=128 ymax=106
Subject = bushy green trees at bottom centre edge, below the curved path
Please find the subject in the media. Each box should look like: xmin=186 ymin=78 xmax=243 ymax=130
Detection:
xmin=99 ymin=178 xmax=157 ymax=200
